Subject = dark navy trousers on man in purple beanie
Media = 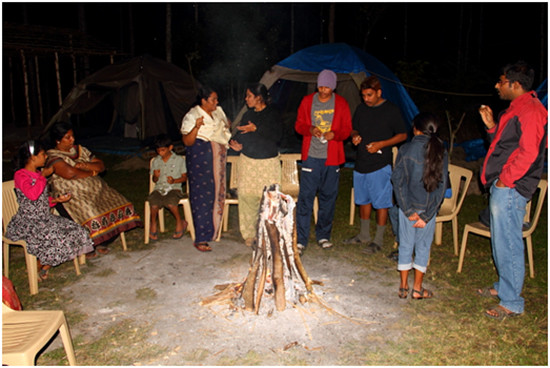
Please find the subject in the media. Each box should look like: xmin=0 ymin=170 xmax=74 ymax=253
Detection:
xmin=296 ymin=157 xmax=340 ymax=246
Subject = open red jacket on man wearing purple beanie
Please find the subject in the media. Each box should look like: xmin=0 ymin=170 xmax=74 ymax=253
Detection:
xmin=295 ymin=93 xmax=351 ymax=166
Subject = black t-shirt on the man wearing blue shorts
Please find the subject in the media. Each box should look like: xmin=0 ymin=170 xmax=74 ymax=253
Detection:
xmin=353 ymin=100 xmax=407 ymax=174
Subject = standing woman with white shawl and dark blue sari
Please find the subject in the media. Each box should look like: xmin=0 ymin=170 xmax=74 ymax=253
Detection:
xmin=181 ymin=87 xmax=231 ymax=252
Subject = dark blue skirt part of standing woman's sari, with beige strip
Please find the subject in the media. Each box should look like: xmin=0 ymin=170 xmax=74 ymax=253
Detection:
xmin=186 ymin=139 xmax=227 ymax=243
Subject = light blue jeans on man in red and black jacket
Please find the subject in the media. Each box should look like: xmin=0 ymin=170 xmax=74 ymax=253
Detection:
xmin=489 ymin=181 xmax=527 ymax=313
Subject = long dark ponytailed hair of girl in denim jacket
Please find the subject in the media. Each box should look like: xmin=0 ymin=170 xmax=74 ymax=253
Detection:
xmin=413 ymin=112 xmax=445 ymax=193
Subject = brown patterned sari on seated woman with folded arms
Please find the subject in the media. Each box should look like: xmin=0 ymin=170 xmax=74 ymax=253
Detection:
xmin=46 ymin=146 xmax=142 ymax=245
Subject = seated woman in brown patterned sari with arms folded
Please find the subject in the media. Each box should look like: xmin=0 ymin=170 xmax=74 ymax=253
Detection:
xmin=46 ymin=122 xmax=141 ymax=257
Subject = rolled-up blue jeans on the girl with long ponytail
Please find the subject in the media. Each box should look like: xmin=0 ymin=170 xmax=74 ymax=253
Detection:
xmin=397 ymin=209 xmax=435 ymax=273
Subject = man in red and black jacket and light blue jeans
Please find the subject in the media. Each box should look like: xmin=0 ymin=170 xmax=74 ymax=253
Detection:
xmin=478 ymin=62 xmax=548 ymax=319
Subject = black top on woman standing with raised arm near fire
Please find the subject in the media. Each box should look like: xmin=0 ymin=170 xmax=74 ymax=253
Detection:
xmin=234 ymin=106 xmax=283 ymax=159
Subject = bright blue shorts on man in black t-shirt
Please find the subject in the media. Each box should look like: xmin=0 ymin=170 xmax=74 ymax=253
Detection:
xmin=353 ymin=165 xmax=393 ymax=209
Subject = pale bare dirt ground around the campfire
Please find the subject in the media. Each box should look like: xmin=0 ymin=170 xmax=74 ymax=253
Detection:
xmin=50 ymin=235 xmax=412 ymax=365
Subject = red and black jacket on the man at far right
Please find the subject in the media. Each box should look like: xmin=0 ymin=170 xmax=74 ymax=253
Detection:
xmin=481 ymin=92 xmax=548 ymax=199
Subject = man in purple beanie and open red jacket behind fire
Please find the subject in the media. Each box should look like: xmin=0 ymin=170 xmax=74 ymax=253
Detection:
xmin=295 ymin=69 xmax=351 ymax=250
